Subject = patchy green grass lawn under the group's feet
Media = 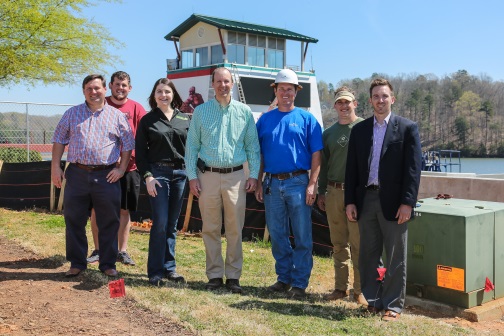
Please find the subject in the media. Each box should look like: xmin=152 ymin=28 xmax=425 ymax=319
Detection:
xmin=0 ymin=208 xmax=474 ymax=336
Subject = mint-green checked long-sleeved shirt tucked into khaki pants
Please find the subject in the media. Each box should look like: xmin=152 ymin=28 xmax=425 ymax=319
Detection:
xmin=185 ymin=99 xmax=261 ymax=180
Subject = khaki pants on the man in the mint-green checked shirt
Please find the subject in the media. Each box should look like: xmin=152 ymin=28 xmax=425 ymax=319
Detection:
xmin=198 ymin=169 xmax=247 ymax=279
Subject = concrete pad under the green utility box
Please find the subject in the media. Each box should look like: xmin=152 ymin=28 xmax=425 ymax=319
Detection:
xmin=405 ymin=295 xmax=504 ymax=322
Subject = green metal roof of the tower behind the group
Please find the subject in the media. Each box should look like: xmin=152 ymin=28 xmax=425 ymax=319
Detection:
xmin=165 ymin=14 xmax=318 ymax=43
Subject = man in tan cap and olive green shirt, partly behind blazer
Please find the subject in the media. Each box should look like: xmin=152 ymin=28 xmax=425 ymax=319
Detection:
xmin=317 ymin=86 xmax=367 ymax=305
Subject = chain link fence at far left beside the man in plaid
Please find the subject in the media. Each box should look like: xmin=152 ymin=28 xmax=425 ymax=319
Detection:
xmin=0 ymin=101 xmax=73 ymax=162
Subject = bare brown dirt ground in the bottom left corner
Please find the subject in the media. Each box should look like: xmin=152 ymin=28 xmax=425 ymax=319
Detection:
xmin=0 ymin=236 xmax=193 ymax=336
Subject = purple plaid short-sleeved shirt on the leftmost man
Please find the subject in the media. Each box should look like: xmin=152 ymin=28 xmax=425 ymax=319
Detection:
xmin=52 ymin=103 xmax=135 ymax=165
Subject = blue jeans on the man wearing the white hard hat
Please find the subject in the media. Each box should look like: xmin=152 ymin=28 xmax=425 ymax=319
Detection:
xmin=263 ymin=174 xmax=313 ymax=289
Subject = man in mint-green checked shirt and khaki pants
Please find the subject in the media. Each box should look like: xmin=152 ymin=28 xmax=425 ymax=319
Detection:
xmin=185 ymin=68 xmax=260 ymax=293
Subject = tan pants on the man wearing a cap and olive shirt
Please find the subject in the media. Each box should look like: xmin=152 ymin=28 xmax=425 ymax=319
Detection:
xmin=326 ymin=186 xmax=361 ymax=294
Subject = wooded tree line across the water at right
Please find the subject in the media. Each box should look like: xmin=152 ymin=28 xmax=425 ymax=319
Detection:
xmin=318 ymin=70 xmax=504 ymax=157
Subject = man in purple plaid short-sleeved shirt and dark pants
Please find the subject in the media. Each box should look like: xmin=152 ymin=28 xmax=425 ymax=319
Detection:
xmin=51 ymin=75 xmax=135 ymax=277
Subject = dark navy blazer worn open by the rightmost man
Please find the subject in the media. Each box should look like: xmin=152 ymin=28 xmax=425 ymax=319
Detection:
xmin=345 ymin=114 xmax=422 ymax=221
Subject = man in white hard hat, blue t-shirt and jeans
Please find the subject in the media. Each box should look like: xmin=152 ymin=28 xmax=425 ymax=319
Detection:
xmin=256 ymin=69 xmax=323 ymax=298
